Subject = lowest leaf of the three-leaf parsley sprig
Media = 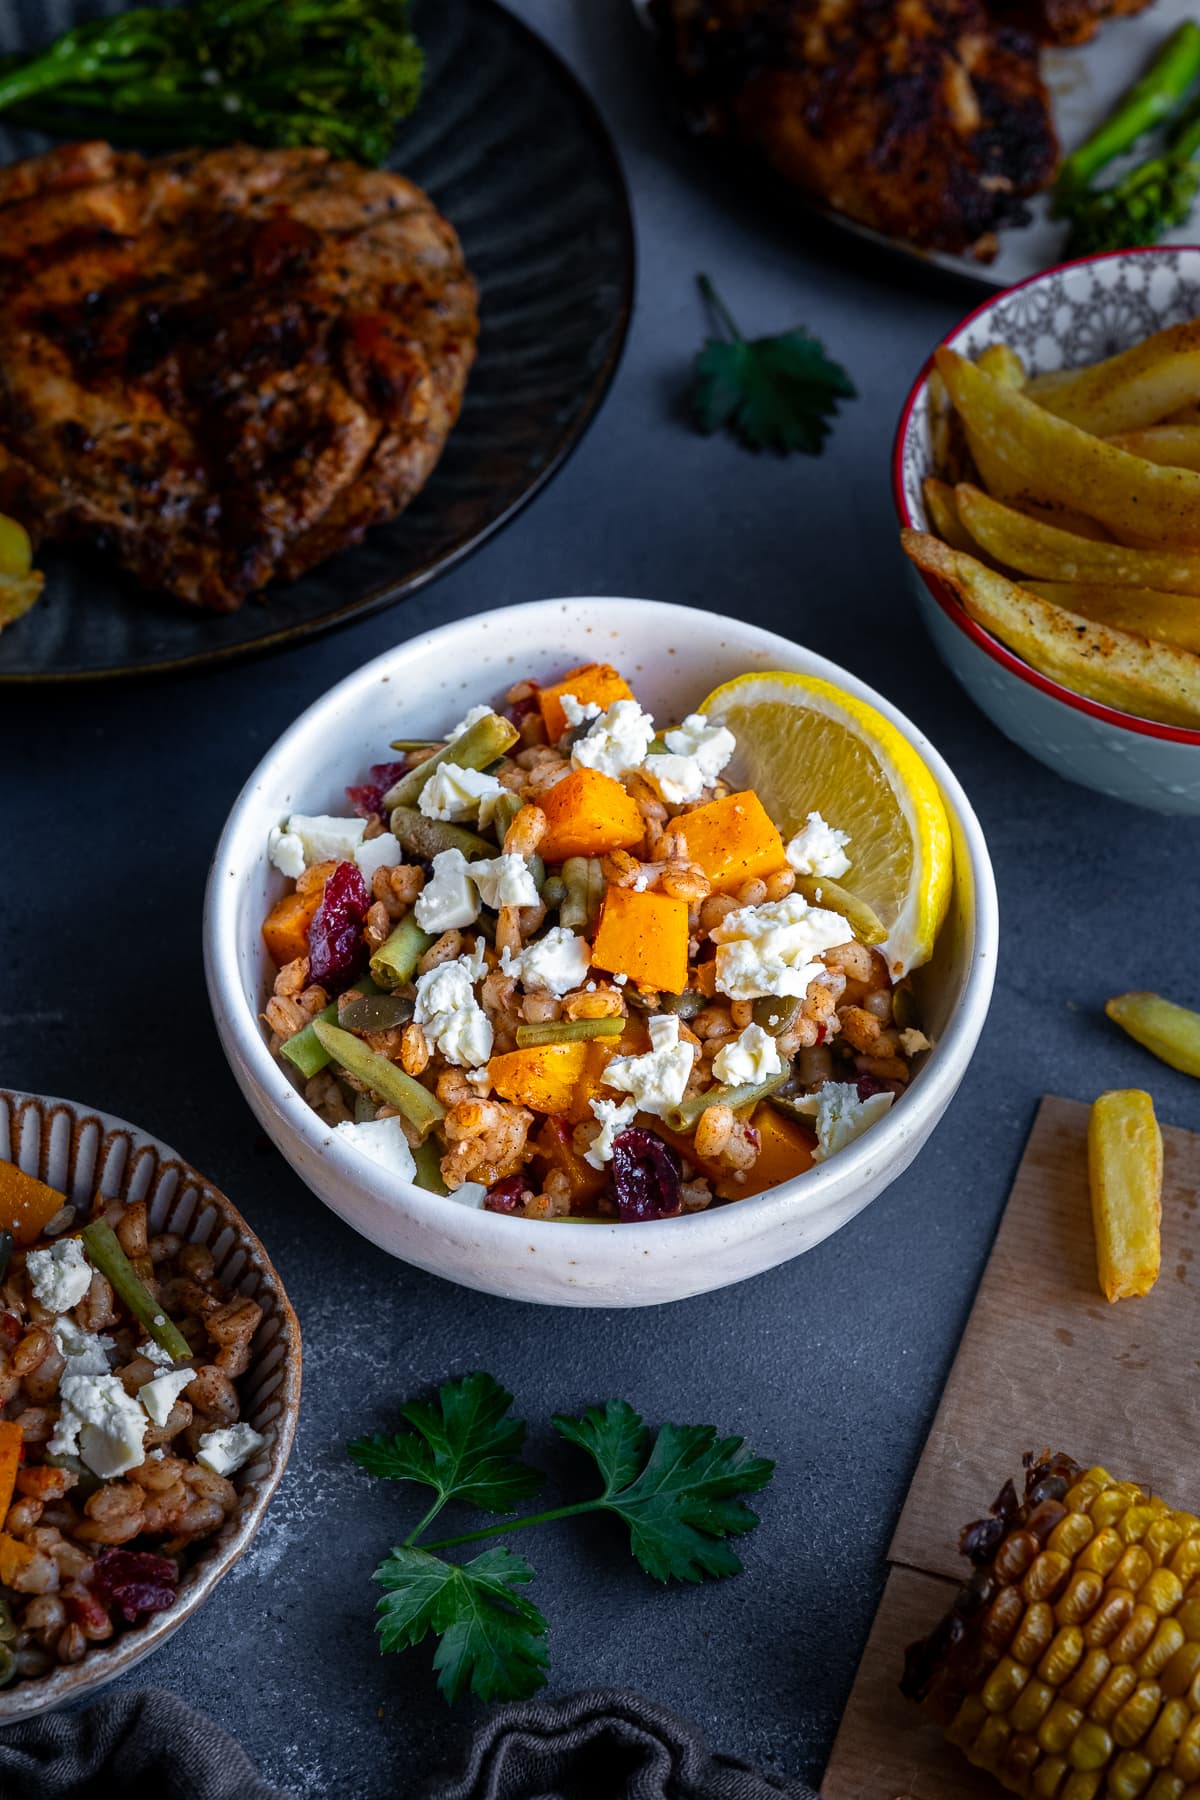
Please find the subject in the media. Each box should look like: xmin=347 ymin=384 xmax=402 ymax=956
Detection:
xmin=374 ymin=1546 xmax=549 ymax=1705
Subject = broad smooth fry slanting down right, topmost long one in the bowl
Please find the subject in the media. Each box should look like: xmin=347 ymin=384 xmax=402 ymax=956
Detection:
xmin=936 ymin=347 xmax=1200 ymax=545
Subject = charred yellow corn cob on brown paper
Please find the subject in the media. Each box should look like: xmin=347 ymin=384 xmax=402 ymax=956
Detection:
xmin=901 ymin=1453 xmax=1200 ymax=1800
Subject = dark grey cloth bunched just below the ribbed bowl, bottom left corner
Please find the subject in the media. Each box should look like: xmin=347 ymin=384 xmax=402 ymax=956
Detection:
xmin=0 ymin=1688 xmax=288 ymax=1800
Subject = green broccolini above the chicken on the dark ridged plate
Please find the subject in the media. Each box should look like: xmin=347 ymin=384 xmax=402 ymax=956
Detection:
xmin=0 ymin=0 xmax=421 ymax=164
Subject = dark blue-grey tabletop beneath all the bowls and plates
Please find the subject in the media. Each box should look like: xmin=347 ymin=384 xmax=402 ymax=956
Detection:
xmin=0 ymin=0 xmax=1200 ymax=1800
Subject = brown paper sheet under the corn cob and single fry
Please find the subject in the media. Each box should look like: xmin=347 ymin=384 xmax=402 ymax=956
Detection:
xmin=822 ymin=1098 xmax=1200 ymax=1800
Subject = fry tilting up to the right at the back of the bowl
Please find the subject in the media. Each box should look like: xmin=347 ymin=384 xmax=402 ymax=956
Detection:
xmin=1029 ymin=319 xmax=1200 ymax=437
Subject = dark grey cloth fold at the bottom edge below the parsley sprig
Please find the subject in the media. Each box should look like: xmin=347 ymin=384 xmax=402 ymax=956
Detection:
xmin=428 ymin=1688 xmax=819 ymax=1800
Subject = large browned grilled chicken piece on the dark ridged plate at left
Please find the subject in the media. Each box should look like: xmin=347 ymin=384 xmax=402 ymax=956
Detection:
xmin=0 ymin=144 xmax=479 ymax=610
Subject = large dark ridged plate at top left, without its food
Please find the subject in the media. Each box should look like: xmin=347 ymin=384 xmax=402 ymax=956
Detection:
xmin=0 ymin=0 xmax=633 ymax=682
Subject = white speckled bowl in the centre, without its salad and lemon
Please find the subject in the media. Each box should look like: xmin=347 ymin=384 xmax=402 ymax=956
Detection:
xmin=203 ymin=598 xmax=997 ymax=1307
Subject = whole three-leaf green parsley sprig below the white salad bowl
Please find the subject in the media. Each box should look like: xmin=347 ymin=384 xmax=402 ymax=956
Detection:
xmin=347 ymin=1373 xmax=775 ymax=1703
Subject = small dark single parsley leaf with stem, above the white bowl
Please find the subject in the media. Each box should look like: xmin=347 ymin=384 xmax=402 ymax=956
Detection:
xmin=691 ymin=275 xmax=856 ymax=455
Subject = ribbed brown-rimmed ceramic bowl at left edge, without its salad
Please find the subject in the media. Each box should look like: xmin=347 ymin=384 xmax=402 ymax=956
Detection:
xmin=0 ymin=1089 xmax=300 ymax=1724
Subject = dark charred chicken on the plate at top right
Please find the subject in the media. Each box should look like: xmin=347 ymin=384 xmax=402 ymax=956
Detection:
xmin=651 ymin=0 xmax=1058 ymax=259
